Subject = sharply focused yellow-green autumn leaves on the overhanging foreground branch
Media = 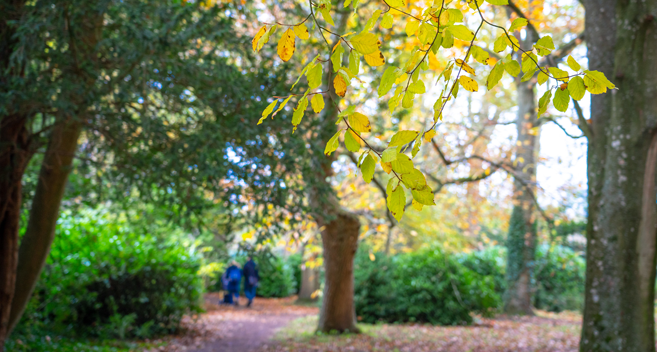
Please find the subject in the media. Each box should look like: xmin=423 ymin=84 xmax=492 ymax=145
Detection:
xmin=252 ymin=0 xmax=615 ymax=220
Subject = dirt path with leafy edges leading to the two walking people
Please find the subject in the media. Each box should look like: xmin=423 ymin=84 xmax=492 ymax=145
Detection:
xmin=159 ymin=294 xmax=318 ymax=352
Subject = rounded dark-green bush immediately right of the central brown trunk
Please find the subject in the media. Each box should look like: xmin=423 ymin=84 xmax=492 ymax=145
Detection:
xmin=354 ymin=248 xmax=499 ymax=325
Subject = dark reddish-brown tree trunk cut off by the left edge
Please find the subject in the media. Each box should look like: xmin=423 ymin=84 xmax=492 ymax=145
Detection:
xmin=0 ymin=115 xmax=32 ymax=351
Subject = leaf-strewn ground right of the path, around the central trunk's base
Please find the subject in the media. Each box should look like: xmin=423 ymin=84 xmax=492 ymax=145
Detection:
xmin=259 ymin=312 xmax=581 ymax=352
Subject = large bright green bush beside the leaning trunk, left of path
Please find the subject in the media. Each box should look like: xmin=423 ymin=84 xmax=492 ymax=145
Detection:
xmin=14 ymin=211 xmax=202 ymax=338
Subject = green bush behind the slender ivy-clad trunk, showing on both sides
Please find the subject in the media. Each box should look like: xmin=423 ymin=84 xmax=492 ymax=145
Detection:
xmin=459 ymin=244 xmax=586 ymax=312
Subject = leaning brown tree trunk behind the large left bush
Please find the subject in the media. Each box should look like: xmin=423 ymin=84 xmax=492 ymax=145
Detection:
xmin=9 ymin=121 xmax=80 ymax=332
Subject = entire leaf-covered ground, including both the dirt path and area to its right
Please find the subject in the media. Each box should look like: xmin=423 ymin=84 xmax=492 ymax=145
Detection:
xmin=156 ymin=294 xmax=581 ymax=352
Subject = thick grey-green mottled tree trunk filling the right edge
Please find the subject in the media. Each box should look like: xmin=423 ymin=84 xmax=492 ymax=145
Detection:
xmin=580 ymin=0 xmax=657 ymax=352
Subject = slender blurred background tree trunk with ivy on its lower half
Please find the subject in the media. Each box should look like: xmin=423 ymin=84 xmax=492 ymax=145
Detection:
xmin=504 ymin=31 xmax=538 ymax=315
